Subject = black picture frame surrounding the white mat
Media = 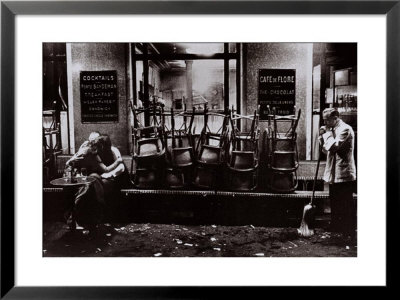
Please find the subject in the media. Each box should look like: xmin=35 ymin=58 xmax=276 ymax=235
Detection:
xmin=1 ymin=0 xmax=400 ymax=299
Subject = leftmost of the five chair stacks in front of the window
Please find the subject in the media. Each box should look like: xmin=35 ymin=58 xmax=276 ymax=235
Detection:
xmin=131 ymin=101 xmax=165 ymax=188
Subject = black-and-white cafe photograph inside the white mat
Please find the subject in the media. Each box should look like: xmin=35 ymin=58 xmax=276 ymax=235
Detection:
xmin=43 ymin=41 xmax=362 ymax=259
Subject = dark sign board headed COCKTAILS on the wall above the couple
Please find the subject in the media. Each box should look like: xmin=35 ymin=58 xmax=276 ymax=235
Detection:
xmin=80 ymin=71 xmax=118 ymax=123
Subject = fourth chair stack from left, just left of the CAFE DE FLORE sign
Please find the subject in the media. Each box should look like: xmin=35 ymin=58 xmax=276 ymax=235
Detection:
xmin=225 ymin=110 xmax=260 ymax=191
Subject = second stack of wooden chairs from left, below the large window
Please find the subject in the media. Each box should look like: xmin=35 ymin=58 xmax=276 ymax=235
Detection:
xmin=164 ymin=108 xmax=195 ymax=189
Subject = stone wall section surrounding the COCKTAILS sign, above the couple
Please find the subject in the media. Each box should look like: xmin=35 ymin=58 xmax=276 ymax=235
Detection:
xmin=67 ymin=43 xmax=129 ymax=154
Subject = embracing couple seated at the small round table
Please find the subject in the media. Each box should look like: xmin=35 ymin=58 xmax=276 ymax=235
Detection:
xmin=66 ymin=132 xmax=129 ymax=229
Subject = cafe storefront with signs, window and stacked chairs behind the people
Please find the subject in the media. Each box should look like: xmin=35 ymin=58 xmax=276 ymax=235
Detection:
xmin=43 ymin=43 xmax=357 ymax=225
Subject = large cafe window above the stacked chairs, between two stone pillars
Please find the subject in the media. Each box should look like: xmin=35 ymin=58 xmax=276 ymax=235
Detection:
xmin=131 ymin=43 xmax=240 ymax=126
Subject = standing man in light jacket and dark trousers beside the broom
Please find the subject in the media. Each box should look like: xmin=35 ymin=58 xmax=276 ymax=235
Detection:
xmin=319 ymin=108 xmax=357 ymax=239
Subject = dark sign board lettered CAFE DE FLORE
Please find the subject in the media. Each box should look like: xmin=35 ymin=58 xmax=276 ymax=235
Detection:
xmin=258 ymin=69 xmax=296 ymax=120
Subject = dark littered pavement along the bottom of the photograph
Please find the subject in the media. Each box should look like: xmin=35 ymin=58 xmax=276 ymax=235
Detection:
xmin=43 ymin=222 xmax=357 ymax=257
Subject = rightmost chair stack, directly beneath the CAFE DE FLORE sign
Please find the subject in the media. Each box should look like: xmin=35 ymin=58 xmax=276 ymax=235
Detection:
xmin=267 ymin=110 xmax=301 ymax=193
